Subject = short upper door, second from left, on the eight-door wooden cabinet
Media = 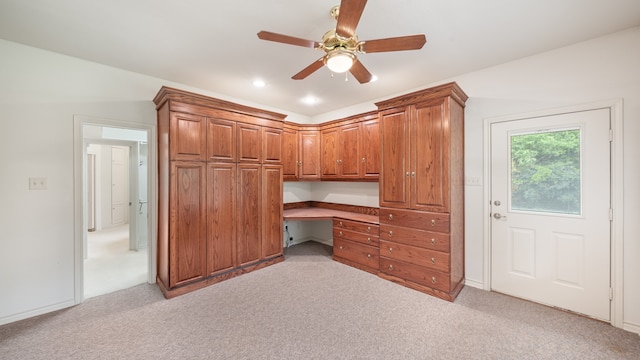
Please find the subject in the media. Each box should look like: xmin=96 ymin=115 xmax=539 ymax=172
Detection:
xmin=207 ymin=118 xmax=236 ymax=162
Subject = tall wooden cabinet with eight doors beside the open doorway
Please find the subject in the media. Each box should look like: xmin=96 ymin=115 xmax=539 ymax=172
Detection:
xmin=154 ymin=87 xmax=284 ymax=298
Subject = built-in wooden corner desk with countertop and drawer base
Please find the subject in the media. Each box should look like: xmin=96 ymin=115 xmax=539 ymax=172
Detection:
xmin=283 ymin=201 xmax=380 ymax=274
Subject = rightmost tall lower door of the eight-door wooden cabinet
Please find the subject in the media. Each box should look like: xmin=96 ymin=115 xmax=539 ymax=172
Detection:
xmin=261 ymin=165 xmax=283 ymax=259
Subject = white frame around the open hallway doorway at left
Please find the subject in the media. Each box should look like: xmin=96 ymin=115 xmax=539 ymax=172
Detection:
xmin=73 ymin=115 xmax=158 ymax=305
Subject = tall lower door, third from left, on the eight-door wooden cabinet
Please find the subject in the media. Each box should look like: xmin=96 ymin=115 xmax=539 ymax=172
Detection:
xmin=236 ymin=164 xmax=262 ymax=265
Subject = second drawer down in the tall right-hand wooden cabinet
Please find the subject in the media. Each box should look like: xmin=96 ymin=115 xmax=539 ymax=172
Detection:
xmin=380 ymin=224 xmax=450 ymax=253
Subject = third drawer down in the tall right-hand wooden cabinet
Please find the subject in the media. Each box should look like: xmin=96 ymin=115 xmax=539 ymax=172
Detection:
xmin=380 ymin=241 xmax=450 ymax=273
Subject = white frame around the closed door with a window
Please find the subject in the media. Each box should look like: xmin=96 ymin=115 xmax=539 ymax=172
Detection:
xmin=483 ymin=99 xmax=624 ymax=328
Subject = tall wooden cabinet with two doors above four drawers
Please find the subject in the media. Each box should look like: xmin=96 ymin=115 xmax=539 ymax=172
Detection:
xmin=376 ymin=83 xmax=467 ymax=300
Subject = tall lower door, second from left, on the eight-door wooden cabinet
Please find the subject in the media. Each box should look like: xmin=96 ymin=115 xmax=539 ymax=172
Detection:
xmin=207 ymin=163 xmax=237 ymax=275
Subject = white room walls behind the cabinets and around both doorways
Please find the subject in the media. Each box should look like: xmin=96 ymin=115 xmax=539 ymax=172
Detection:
xmin=0 ymin=28 xmax=640 ymax=331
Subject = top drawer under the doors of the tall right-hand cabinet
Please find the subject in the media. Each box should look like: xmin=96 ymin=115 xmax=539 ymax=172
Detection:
xmin=380 ymin=208 xmax=449 ymax=233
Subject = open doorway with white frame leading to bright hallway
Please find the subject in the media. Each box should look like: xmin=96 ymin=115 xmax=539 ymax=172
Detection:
xmin=74 ymin=116 xmax=156 ymax=303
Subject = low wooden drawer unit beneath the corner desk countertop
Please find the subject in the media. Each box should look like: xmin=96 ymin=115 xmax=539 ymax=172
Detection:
xmin=333 ymin=218 xmax=379 ymax=274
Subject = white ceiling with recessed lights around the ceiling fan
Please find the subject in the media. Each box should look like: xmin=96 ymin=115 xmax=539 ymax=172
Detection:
xmin=0 ymin=0 xmax=640 ymax=116
